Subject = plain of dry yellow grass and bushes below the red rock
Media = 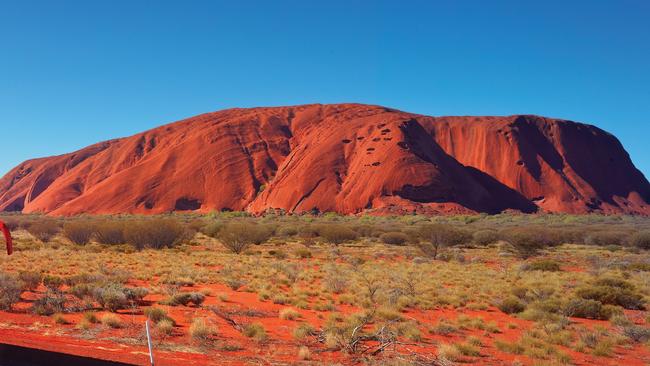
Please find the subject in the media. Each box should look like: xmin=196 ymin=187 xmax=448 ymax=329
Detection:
xmin=0 ymin=212 xmax=650 ymax=364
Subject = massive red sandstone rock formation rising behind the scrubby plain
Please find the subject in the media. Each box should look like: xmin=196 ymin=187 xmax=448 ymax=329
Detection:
xmin=0 ymin=104 xmax=650 ymax=215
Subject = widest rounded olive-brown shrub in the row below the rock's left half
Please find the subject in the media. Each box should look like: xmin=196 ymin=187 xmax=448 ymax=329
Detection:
xmin=124 ymin=219 xmax=187 ymax=249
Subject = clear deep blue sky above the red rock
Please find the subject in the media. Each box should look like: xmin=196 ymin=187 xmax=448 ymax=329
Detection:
xmin=0 ymin=0 xmax=650 ymax=177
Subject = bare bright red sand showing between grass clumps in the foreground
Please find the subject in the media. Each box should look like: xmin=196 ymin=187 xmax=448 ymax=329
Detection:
xmin=0 ymin=283 xmax=650 ymax=366
